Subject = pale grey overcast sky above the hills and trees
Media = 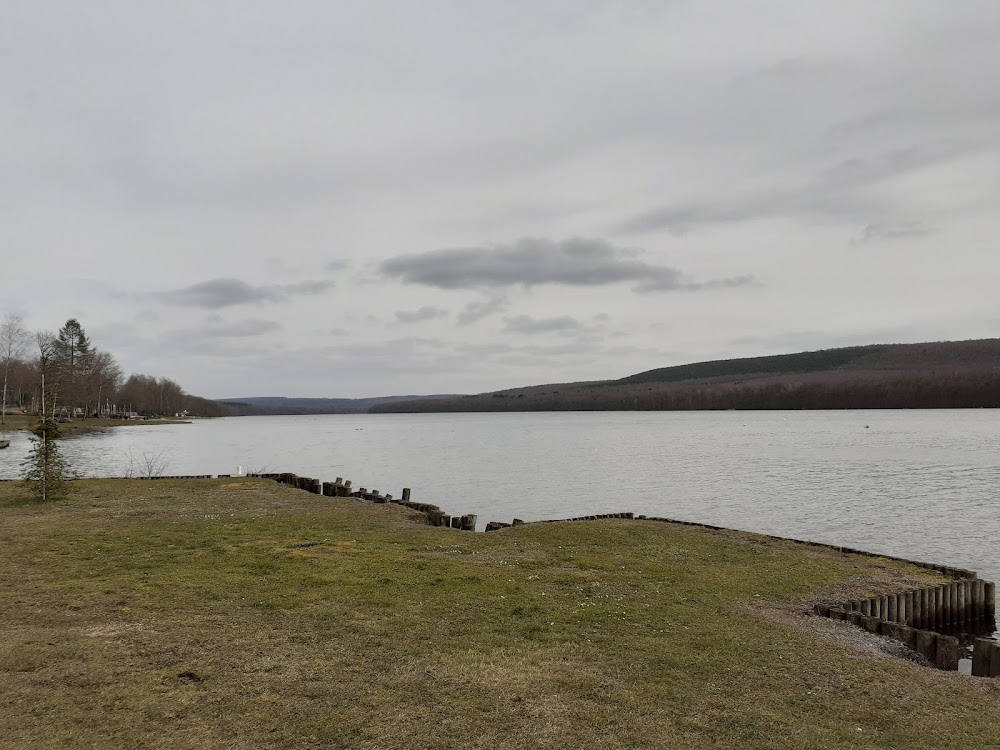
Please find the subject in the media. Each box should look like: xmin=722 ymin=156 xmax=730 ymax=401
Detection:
xmin=0 ymin=0 xmax=1000 ymax=397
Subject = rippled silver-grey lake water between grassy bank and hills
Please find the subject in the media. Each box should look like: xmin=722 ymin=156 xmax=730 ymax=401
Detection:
xmin=0 ymin=409 xmax=1000 ymax=592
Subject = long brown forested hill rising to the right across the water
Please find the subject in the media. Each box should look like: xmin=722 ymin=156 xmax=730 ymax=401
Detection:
xmin=370 ymin=339 xmax=1000 ymax=412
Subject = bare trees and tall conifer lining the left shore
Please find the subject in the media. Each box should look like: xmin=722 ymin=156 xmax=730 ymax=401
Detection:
xmin=0 ymin=315 xmax=229 ymax=420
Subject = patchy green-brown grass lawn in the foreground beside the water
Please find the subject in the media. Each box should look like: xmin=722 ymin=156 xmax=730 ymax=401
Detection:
xmin=0 ymin=480 xmax=1000 ymax=750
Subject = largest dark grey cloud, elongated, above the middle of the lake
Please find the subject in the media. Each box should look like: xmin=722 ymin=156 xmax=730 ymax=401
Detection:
xmin=381 ymin=237 xmax=745 ymax=292
